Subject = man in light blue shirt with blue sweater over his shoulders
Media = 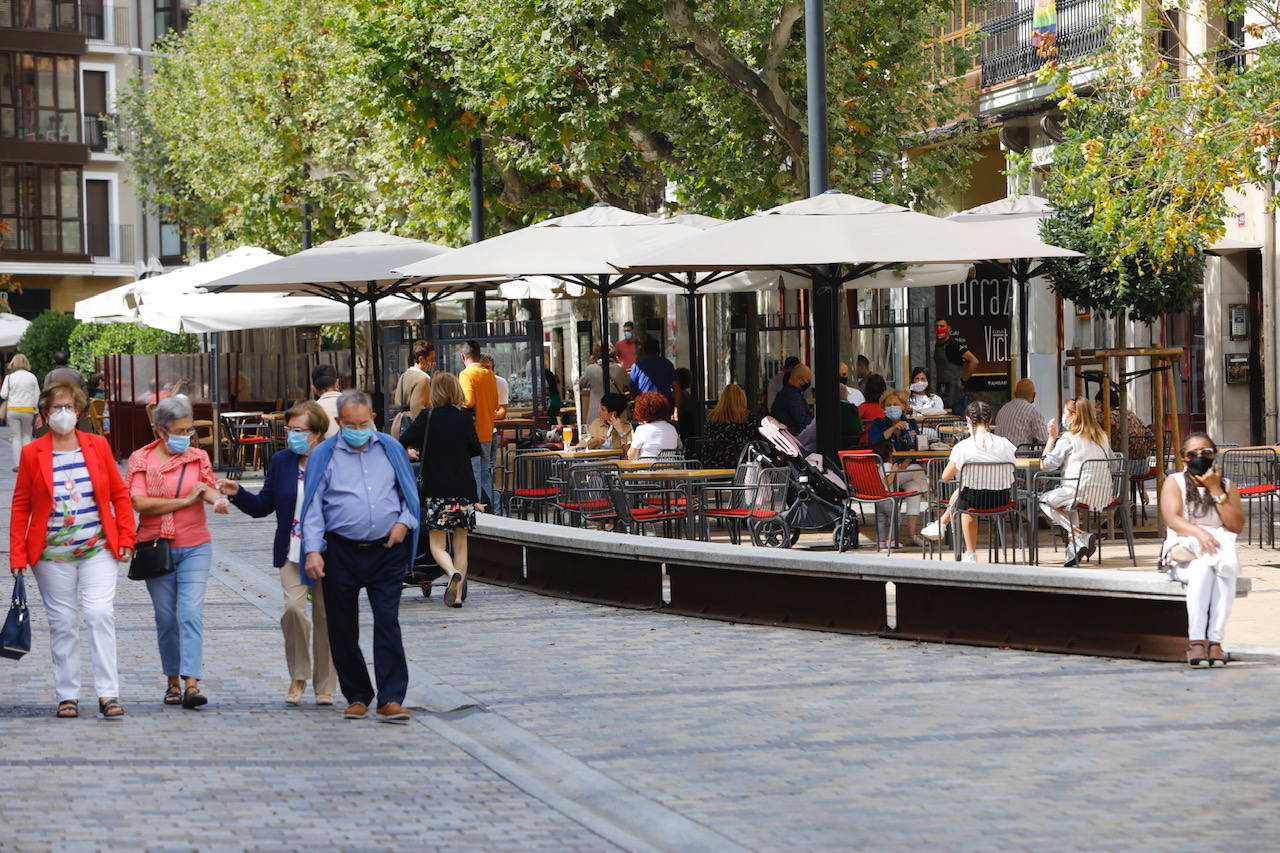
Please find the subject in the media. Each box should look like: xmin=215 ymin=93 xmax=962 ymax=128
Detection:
xmin=301 ymin=389 xmax=419 ymax=722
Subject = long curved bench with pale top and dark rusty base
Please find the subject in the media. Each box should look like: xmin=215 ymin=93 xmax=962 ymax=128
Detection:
xmin=468 ymin=514 xmax=1251 ymax=661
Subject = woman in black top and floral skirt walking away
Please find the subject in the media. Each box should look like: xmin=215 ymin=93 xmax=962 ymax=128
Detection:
xmin=402 ymin=373 xmax=481 ymax=607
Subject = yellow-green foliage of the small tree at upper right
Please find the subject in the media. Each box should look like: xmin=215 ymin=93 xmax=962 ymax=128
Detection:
xmin=1042 ymin=0 xmax=1280 ymax=321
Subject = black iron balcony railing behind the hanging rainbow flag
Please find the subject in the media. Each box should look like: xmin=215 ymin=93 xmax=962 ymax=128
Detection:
xmin=980 ymin=0 xmax=1107 ymax=87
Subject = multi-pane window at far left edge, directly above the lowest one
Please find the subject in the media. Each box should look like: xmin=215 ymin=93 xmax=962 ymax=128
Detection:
xmin=0 ymin=54 xmax=81 ymax=142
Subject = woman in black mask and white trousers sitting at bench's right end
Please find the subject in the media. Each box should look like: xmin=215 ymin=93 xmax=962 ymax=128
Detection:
xmin=1160 ymin=433 xmax=1244 ymax=666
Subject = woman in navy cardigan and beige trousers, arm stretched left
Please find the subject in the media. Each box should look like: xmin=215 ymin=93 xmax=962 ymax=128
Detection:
xmin=218 ymin=400 xmax=338 ymax=704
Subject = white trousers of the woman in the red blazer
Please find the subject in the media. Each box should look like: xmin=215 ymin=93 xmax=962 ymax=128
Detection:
xmin=32 ymin=551 xmax=120 ymax=702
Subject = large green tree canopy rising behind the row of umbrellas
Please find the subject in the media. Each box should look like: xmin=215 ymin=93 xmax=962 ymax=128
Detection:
xmin=120 ymin=0 xmax=975 ymax=251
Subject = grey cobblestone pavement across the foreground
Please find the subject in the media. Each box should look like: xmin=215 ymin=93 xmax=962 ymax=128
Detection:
xmin=0 ymin=433 xmax=1280 ymax=850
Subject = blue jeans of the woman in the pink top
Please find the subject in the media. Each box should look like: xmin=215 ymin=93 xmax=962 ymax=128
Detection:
xmin=147 ymin=543 xmax=214 ymax=679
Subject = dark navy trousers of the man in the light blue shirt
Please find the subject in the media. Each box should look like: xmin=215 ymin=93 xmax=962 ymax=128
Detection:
xmin=323 ymin=538 xmax=412 ymax=706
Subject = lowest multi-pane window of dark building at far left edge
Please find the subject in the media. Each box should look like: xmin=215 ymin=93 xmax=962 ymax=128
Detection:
xmin=0 ymin=163 xmax=83 ymax=255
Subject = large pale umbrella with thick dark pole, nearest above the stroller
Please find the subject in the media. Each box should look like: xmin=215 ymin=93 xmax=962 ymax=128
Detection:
xmin=617 ymin=191 xmax=1076 ymax=453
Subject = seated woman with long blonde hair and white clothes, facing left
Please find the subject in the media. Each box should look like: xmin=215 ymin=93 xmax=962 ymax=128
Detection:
xmin=1039 ymin=397 xmax=1111 ymax=566
